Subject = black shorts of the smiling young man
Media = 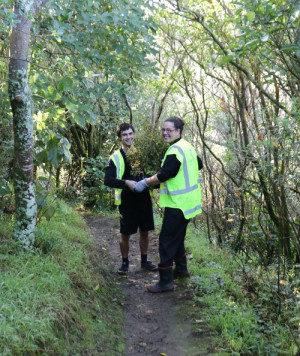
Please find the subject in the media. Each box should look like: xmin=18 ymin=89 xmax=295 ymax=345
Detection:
xmin=119 ymin=197 xmax=154 ymax=235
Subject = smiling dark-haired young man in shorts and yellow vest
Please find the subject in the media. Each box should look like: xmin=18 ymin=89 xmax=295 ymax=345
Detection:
xmin=104 ymin=123 xmax=157 ymax=275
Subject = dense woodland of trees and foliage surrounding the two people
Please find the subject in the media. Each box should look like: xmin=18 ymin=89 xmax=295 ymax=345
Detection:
xmin=0 ymin=0 xmax=300 ymax=354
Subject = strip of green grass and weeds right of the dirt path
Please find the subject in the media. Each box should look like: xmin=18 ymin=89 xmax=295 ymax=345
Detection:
xmin=186 ymin=224 xmax=300 ymax=356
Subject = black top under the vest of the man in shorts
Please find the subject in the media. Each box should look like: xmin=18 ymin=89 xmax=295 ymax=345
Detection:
xmin=104 ymin=148 xmax=152 ymax=209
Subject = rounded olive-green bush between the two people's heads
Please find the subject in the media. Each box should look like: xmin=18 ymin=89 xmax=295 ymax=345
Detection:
xmin=127 ymin=125 xmax=168 ymax=176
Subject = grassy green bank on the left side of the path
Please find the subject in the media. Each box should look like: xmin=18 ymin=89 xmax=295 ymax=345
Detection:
xmin=0 ymin=202 xmax=124 ymax=356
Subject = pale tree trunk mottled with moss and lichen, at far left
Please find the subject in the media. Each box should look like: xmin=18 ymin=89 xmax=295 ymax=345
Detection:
xmin=8 ymin=0 xmax=47 ymax=249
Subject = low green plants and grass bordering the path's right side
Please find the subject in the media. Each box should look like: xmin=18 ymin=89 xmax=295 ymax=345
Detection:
xmin=187 ymin=227 xmax=300 ymax=356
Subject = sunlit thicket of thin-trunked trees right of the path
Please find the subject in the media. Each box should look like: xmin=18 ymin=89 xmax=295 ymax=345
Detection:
xmin=158 ymin=0 xmax=300 ymax=265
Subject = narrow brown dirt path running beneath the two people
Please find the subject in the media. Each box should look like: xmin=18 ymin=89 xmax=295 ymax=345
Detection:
xmin=85 ymin=215 xmax=217 ymax=356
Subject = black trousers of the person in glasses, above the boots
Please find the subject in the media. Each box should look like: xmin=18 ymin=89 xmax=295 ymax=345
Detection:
xmin=159 ymin=208 xmax=190 ymax=267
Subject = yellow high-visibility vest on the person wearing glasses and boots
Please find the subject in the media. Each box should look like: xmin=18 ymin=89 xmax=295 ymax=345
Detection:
xmin=159 ymin=139 xmax=202 ymax=219
